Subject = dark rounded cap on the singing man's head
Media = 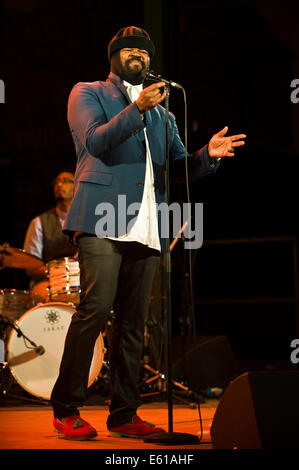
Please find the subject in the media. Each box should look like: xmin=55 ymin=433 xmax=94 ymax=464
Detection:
xmin=108 ymin=26 xmax=155 ymax=60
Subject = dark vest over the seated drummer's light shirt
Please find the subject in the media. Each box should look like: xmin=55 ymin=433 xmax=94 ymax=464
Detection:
xmin=40 ymin=207 xmax=77 ymax=263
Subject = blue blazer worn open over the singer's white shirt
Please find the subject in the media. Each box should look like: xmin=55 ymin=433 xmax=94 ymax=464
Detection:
xmin=63 ymin=72 xmax=215 ymax=246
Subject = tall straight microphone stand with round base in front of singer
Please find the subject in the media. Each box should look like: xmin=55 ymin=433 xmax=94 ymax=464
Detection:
xmin=144 ymin=85 xmax=200 ymax=445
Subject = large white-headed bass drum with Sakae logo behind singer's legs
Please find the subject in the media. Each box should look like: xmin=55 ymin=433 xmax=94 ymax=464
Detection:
xmin=7 ymin=302 xmax=105 ymax=400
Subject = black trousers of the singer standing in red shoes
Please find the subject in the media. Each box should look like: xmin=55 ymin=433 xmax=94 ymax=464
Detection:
xmin=51 ymin=241 xmax=160 ymax=428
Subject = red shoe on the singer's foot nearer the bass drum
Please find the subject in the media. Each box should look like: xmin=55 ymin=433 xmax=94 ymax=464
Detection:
xmin=53 ymin=415 xmax=97 ymax=441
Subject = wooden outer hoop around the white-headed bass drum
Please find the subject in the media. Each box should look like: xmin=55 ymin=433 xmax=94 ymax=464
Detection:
xmin=5 ymin=302 xmax=105 ymax=401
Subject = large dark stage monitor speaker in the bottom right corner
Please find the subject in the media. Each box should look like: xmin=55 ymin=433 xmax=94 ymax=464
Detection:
xmin=211 ymin=371 xmax=299 ymax=449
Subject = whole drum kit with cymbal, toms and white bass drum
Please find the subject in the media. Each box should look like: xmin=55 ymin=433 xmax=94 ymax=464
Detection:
xmin=0 ymin=243 xmax=106 ymax=401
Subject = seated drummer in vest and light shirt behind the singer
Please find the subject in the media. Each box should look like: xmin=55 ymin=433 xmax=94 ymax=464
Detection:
xmin=24 ymin=171 xmax=77 ymax=287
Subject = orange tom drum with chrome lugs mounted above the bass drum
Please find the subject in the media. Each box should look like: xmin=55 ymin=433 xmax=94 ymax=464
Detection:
xmin=48 ymin=257 xmax=80 ymax=305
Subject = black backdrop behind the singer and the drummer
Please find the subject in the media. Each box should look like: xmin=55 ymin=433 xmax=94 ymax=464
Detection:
xmin=0 ymin=0 xmax=299 ymax=368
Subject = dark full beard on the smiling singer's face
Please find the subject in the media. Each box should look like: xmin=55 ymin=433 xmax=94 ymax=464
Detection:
xmin=111 ymin=51 xmax=148 ymax=85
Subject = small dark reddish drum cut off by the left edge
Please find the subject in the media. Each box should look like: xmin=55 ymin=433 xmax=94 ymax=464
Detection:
xmin=0 ymin=289 xmax=32 ymax=322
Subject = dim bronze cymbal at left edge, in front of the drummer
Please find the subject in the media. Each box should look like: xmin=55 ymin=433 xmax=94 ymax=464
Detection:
xmin=0 ymin=243 xmax=44 ymax=269
